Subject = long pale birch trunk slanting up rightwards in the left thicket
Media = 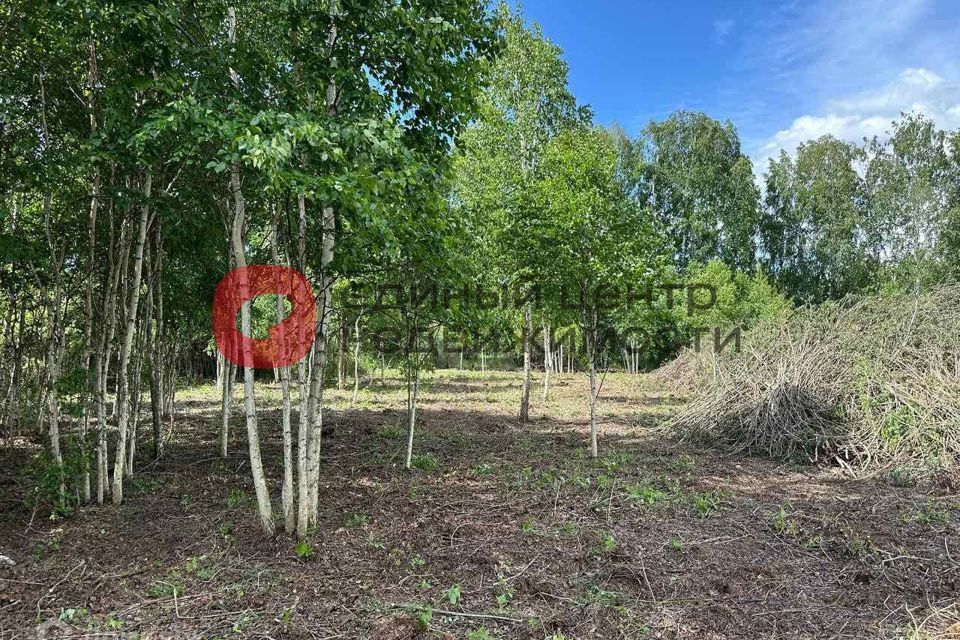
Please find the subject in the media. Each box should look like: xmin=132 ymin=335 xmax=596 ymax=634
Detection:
xmin=113 ymin=173 xmax=153 ymax=505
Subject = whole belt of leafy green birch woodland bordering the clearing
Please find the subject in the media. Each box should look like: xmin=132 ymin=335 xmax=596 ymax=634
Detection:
xmin=0 ymin=0 xmax=960 ymax=535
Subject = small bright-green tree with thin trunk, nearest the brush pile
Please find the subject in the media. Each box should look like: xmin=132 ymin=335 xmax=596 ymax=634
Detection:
xmin=529 ymin=127 xmax=662 ymax=458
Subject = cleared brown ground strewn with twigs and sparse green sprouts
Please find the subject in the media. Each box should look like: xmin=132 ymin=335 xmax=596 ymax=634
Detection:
xmin=0 ymin=371 xmax=960 ymax=640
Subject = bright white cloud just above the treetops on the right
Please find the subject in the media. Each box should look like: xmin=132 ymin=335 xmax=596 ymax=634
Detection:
xmin=753 ymin=68 xmax=960 ymax=174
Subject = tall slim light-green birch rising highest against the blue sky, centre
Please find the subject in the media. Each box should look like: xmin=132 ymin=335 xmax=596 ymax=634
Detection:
xmin=456 ymin=4 xmax=589 ymax=422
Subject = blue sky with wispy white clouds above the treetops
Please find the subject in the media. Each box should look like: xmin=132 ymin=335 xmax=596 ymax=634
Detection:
xmin=522 ymin=0 xmax=960 ymax=167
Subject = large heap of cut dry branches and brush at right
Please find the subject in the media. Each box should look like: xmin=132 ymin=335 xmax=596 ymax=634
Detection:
xmin=667 ymin=285 xmax=960 ymax=472
